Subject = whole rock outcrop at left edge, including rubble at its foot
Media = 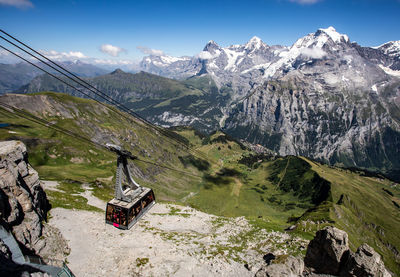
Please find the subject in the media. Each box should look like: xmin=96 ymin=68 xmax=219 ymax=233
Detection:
xmin=0 ymin=141 xmax=68 ymax=276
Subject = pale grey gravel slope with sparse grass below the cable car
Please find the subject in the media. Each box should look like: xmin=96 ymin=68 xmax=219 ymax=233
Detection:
xmin=49 ymin=184 xmax=305 ymax=277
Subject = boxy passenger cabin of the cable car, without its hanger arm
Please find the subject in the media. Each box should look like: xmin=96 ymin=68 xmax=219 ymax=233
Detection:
xmin=106 ymin=188 xmax=155 ymax=230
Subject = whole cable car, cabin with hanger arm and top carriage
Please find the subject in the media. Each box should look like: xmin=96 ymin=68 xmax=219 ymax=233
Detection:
xmin=106 ymin=143 xmax=156 ymax=230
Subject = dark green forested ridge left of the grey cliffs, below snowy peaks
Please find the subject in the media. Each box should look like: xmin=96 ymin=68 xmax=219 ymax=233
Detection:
xmin=21 ymin=71 xmax=230 ymax=131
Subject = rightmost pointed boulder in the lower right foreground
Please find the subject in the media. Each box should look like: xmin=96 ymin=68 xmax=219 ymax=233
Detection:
xmin=340 ymin=244 xmax=392 ymax=277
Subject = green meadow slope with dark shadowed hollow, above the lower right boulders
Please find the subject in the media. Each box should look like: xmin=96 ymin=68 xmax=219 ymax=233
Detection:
xmin=173 ymin=131 xmax=400 ymax=274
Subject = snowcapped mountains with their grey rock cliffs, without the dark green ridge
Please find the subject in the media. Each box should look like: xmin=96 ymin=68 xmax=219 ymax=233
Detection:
xmin=138 ymin=27 xmax=400 ymax=178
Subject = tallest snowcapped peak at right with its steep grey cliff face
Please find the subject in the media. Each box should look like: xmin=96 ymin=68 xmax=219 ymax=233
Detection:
xmin=225 ymin=29 xmax=400 ymax=176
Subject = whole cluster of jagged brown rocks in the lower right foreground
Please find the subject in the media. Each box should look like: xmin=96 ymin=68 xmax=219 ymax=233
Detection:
xmin=255 ymin=227 xmax=392 ymax=277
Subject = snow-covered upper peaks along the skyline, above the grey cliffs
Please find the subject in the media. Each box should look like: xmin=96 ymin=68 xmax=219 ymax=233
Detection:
xmin=140 ymin=27 xmax=400 ymax=97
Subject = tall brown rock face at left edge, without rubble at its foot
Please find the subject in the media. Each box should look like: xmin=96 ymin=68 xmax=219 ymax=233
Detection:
xmin=0 ymin=141 xmax=49 ymax=253
